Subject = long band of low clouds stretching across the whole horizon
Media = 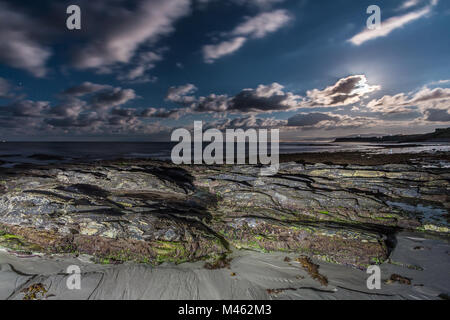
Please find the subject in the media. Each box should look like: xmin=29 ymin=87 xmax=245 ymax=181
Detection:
xmin=5 ymin=75 xmax=442 ymax=139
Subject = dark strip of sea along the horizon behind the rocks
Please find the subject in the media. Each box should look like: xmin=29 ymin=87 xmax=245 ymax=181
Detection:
xmin=0 ymin=142 xmax=450 ymax=167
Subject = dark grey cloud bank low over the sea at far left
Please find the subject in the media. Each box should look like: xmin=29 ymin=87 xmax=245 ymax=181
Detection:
xmin=0 ymin=82 xmax=178 ymax=136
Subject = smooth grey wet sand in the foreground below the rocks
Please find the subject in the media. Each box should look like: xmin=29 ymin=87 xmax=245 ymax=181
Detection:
xmin=0 ymin=233 xmax=450 ymax=300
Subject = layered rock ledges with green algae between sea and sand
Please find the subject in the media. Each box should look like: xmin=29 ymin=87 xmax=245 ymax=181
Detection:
xmin=0 ymin=154 xmax=450 ymax=269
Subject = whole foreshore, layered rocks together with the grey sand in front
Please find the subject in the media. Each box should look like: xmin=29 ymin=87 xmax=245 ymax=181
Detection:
xmin=0 ymin=152 xmax=450 ymax=299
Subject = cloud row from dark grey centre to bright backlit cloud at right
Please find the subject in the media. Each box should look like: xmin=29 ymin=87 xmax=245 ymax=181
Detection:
xmin=167 ymin=75 xmax=380 ymax=113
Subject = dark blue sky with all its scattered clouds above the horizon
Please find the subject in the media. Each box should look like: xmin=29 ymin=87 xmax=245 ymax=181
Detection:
xmin=0 ymin=0 xmax=450 ymax=140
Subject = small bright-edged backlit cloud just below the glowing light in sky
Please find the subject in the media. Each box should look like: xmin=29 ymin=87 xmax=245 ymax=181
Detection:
xmin=304 ymin=75 xmax=381 ymax=107
